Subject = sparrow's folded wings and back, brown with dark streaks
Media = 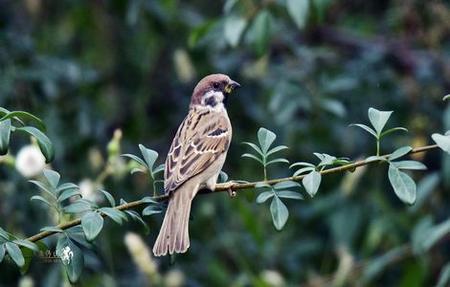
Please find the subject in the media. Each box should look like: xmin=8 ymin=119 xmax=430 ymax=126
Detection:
xmin=164 ymin=109 xmax=231 ymax=196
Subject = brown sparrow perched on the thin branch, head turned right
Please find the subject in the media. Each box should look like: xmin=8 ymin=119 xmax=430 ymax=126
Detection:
xmin=153 ymin=74 xmax=240 ymax=256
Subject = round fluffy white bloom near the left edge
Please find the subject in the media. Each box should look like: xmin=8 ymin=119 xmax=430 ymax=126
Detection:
xmin=16 ymin=145 xmax=45 ymax=178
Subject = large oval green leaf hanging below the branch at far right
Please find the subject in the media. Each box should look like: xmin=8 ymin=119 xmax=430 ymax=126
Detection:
xmin=388 ymin=164 xmax=416 ymax=204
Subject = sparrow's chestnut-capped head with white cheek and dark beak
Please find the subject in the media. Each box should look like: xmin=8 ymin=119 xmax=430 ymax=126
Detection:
xmin=191 ymin=74 xmax=241 ymax=108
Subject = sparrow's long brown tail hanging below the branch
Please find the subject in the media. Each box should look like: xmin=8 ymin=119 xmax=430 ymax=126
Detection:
xmin=153 ymin=183 xmax=197 ymax=256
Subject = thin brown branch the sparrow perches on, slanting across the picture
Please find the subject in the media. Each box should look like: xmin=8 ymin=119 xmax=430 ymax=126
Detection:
xmin=27 ymin=145 xmax=438 ymax=242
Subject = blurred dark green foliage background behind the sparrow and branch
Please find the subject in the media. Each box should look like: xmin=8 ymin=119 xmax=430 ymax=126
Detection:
xmin=0 ymin=0 xmax=450 ymax=286
